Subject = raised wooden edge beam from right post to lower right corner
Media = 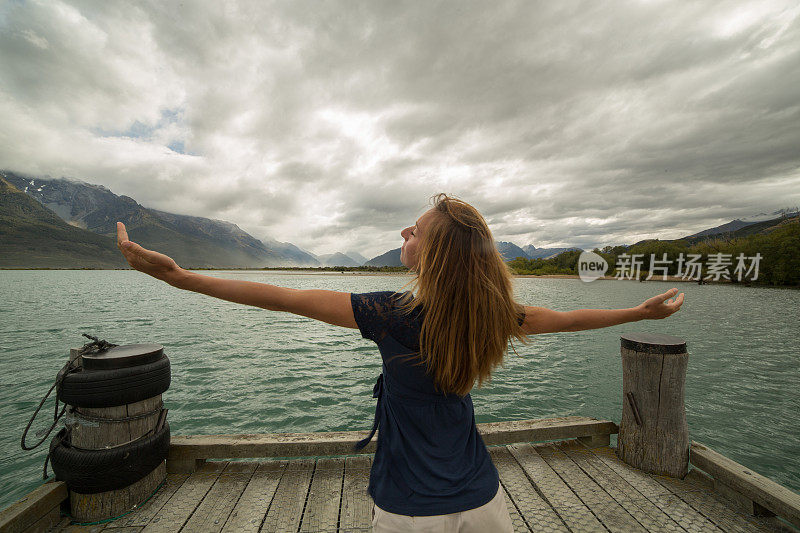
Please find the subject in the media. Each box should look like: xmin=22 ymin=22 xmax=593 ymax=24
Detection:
xmin=690 ymin=441 xmax=800 ymax=528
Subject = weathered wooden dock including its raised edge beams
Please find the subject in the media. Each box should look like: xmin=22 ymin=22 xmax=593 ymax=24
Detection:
xmin=0 ymin=416 xmax=800 ymax=533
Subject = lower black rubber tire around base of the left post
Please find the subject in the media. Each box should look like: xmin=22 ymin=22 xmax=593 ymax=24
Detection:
xmin=50 ymin=422 xmax=170 ymax=494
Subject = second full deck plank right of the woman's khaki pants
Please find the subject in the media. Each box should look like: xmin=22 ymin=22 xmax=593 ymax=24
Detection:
xmin=508 ymin=443 xmax=606 ymax=532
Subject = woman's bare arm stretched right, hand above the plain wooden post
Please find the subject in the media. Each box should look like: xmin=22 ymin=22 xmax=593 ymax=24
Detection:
xmin=522 ymin=288 xmax=683 ymax=335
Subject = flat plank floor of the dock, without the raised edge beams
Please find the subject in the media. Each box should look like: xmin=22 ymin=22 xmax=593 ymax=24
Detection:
xmin=34 ymin=440 xmax=796 ymax=533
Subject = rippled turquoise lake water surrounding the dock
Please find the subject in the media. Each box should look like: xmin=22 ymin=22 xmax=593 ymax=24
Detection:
xmin=0 ymin=270 xmax=800 ymax=508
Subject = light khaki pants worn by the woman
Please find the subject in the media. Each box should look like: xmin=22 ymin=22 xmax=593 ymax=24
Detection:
xmin=372 ymin=486 xmax=514 ymax=533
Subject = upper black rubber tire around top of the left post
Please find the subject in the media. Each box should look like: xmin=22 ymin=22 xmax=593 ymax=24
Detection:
xmin=57 ymin=355 xmax=172 ymax=407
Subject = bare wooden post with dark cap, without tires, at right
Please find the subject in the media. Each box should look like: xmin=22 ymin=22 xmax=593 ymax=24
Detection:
xmin=616 ymin=333 xmax=689 ymax=479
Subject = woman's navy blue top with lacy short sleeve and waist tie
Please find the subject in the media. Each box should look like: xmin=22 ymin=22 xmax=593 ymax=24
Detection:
xmin=350 ymin=291 xmax=522 ymax=516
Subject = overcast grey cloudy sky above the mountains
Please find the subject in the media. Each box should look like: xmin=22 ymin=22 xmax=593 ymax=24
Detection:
xmin=0 ymin=0 xmax=800 ymax=257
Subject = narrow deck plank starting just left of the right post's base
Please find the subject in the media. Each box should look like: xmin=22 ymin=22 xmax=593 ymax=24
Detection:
xmin=591 ymin=442 xmax=722 ymax=532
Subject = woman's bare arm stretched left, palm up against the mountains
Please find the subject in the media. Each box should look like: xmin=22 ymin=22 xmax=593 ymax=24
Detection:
xmin=117 ymin=222 xmax=358 ymax=328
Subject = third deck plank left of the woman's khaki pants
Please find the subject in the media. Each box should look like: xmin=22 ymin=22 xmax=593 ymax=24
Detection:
xmin=262 ymin=459 xmax=314 ymax=533
